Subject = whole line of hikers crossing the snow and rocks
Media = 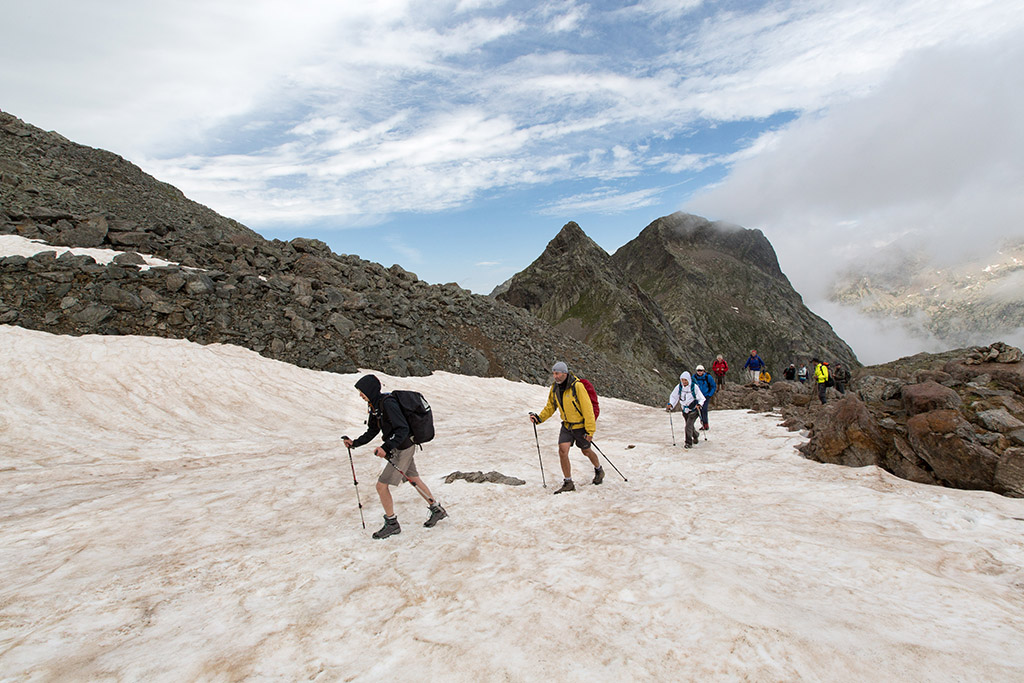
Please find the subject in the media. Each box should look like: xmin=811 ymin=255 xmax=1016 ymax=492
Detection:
xmin=342 ymin=349 xmax=850 ymax=539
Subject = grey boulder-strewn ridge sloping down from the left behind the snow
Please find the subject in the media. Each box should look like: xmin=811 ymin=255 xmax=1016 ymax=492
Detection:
xmin=0 ymin=113 xmax=650 ymax=401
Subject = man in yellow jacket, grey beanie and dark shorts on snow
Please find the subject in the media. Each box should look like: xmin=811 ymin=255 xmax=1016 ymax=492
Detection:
xmin=529 ymin=360 xmax=604 ymax=494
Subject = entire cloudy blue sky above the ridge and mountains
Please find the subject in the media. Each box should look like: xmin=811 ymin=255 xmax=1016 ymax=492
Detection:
xmin=6 ymin=0 xmax=1024 ymax=360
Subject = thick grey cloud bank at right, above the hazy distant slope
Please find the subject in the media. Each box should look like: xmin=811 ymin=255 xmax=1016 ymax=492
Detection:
xmin=687 ymin=34 xmax=1024 ymax=357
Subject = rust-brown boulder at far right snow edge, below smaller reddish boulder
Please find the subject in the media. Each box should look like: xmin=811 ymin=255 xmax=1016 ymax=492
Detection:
xmin=906 ymin=411 xmax=998 ymax=490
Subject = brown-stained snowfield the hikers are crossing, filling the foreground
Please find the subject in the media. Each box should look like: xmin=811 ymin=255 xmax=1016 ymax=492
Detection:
xmin=0 ymin=326 xmax=1024 ymax=681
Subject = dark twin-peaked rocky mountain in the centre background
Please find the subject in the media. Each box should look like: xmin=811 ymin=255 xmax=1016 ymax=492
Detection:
xmin=492 ymin=213 xmax=859 ymax=380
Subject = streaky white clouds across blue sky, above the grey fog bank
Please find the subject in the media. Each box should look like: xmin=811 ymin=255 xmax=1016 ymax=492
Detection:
xmin=0 ymin=0 xmax=1024 ymax=235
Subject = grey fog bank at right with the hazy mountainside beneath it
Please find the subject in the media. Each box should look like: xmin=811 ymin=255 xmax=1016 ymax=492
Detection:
xmin=687 ymin=35 xmax=1024 ymax=362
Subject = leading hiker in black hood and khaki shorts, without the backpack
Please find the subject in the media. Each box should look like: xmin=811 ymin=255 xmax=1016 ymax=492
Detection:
xmin=345 ymin=375 xmax=447 ymax=539
